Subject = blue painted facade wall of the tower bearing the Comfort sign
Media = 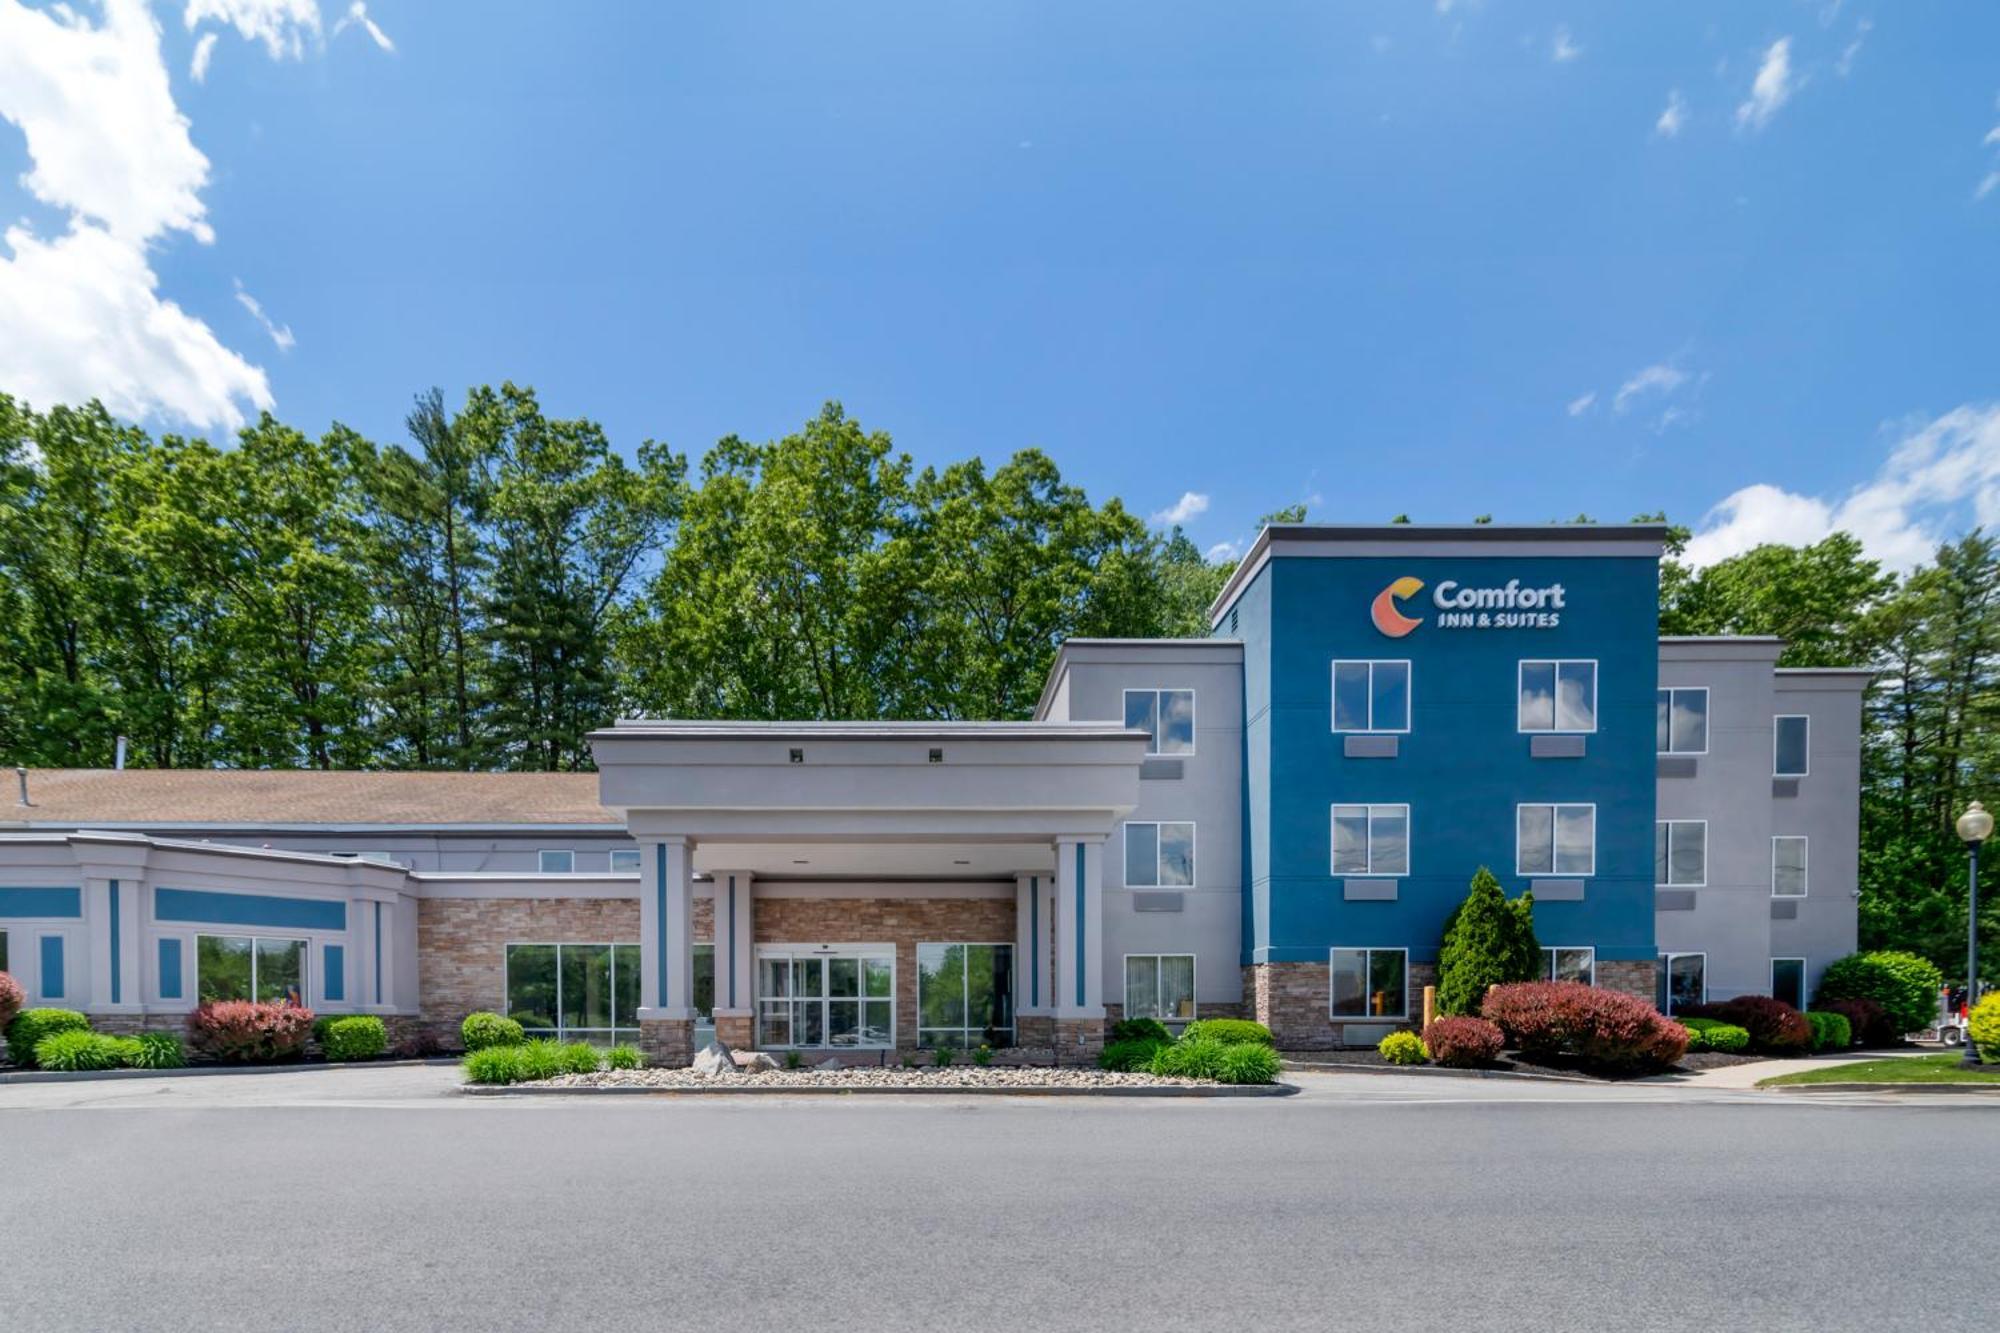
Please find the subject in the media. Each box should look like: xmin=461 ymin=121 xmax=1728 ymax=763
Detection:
xmin=1236 ymin=554 xmax=1658 ymax=963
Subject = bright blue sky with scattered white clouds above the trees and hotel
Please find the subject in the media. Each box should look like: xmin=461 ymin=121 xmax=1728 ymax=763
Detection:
xmin=0 ymin=0 xmax=2000 ymax=564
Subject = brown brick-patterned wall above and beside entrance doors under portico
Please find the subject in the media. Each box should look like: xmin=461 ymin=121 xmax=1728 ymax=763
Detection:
xmin=750 ymin=897 xmax=1014 ymax=1047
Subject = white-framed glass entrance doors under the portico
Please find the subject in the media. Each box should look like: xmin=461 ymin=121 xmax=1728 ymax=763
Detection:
xmin=756 ymin=949 xmax=896 ymax=1047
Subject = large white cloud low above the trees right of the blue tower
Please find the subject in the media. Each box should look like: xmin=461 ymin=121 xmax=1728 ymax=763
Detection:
xmin=1688 ymin=402 xmax=2000 ymax=570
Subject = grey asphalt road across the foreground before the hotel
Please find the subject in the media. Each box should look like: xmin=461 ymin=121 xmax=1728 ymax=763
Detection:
xmin=0 ymin=1069 xmax=2000 ymax=1333
